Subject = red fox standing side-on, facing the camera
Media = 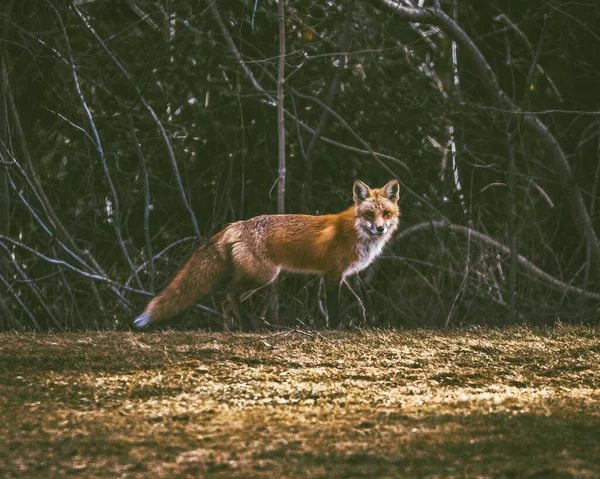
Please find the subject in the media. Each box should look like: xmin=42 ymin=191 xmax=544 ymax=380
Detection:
xmin=134 ymin=180 xmax=400 ymax=329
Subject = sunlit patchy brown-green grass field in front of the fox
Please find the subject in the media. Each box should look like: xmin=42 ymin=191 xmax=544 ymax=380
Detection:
xmin=0 ymin=326 xmax=600 ymax=478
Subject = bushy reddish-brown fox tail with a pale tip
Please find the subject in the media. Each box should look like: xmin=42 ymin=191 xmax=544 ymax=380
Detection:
xmin=133 ymin=241 xmax=228 ymax=328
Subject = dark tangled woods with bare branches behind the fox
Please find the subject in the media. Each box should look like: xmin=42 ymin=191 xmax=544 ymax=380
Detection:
xmin=0 ymin=0 xmax=600 ymax=330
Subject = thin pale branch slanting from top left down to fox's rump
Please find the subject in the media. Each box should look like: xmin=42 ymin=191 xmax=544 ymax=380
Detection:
xmin=72 ymin=4 xmax=202 ymax=237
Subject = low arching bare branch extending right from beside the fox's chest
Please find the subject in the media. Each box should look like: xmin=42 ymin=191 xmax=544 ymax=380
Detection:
xmin=393 ymin=221 xmax=600 ymax=301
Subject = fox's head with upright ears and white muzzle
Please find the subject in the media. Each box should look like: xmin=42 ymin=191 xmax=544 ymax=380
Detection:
xmin=352 ymin=180 xmax=400 ymax=237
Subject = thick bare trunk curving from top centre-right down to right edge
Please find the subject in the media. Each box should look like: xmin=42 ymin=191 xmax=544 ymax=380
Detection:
xmin=370 ymin=0 xmax=600 ymax=279
